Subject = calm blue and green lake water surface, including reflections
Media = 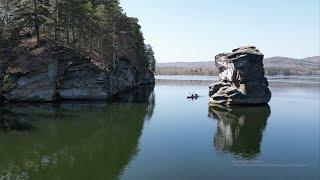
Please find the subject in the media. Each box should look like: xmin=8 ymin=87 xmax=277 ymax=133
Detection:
xmin=0 ymin=76 xmax=320 ymax=180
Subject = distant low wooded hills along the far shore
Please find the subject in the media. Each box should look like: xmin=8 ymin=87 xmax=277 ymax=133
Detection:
xmin=156 ymin=56 xmax=320 ymax=76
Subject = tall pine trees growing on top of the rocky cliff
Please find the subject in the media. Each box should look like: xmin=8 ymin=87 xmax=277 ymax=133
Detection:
xmin=0 ymin=0 xmax=155 ymax=70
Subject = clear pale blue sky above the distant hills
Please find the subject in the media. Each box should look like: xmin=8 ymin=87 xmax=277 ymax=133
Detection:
xmin=120 ymin=0 xmax=320 ymax=62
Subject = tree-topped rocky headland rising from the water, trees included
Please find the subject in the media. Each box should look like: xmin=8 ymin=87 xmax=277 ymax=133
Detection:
xmin=0 ymin=1 xmax=155 ymax=102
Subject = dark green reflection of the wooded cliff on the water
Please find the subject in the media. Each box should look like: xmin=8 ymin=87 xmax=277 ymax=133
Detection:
xmin=0 ymin=84 xmax=155 ymax=179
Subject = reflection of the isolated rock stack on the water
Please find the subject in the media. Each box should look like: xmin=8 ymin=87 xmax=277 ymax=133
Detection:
xmin=209 ymin=105 xmax=271 ymax=158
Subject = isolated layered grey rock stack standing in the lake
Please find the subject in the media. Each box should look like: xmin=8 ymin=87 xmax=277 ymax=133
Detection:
xmin=209 ymin=46 xmax=271 ymax=104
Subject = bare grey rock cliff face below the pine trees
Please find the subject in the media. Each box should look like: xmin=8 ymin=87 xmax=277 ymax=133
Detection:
xmin=0 ymin=39 xmax=155 ymax=102
